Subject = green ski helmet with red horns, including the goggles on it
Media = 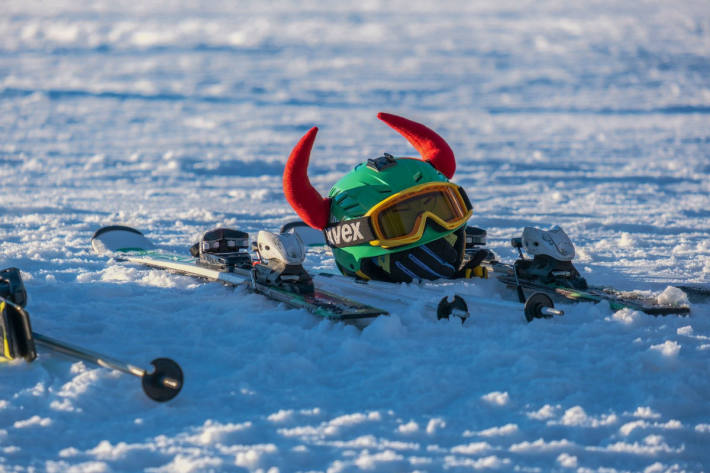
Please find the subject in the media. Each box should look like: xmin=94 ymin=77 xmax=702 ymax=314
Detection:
xmin=283 ymin=113 xmax=472 ymax=282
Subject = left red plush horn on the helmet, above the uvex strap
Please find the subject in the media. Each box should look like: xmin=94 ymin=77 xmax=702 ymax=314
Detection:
xmin=283 ymin=127 xmax=330 ymax=230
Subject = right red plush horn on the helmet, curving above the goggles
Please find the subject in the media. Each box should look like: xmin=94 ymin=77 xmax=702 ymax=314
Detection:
xmin=377 ymin=113 xmax=456 ymax=179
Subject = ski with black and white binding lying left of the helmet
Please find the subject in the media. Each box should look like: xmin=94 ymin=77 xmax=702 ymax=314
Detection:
xmin=91 ymin=225 xmax=388 ymax=325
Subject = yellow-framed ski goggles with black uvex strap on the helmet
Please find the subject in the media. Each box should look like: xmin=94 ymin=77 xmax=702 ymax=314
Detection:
xmin=323 ymin=182 xmax=473 ymax=248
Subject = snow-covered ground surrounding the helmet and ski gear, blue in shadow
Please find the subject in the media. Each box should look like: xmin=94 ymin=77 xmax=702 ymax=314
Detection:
xmin=0 ymin=0 xmax=710 ymax=473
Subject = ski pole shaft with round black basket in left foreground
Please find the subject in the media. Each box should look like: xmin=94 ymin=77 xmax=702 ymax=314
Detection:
xmin=32 ymin=332 xmax=183 ymax=402
